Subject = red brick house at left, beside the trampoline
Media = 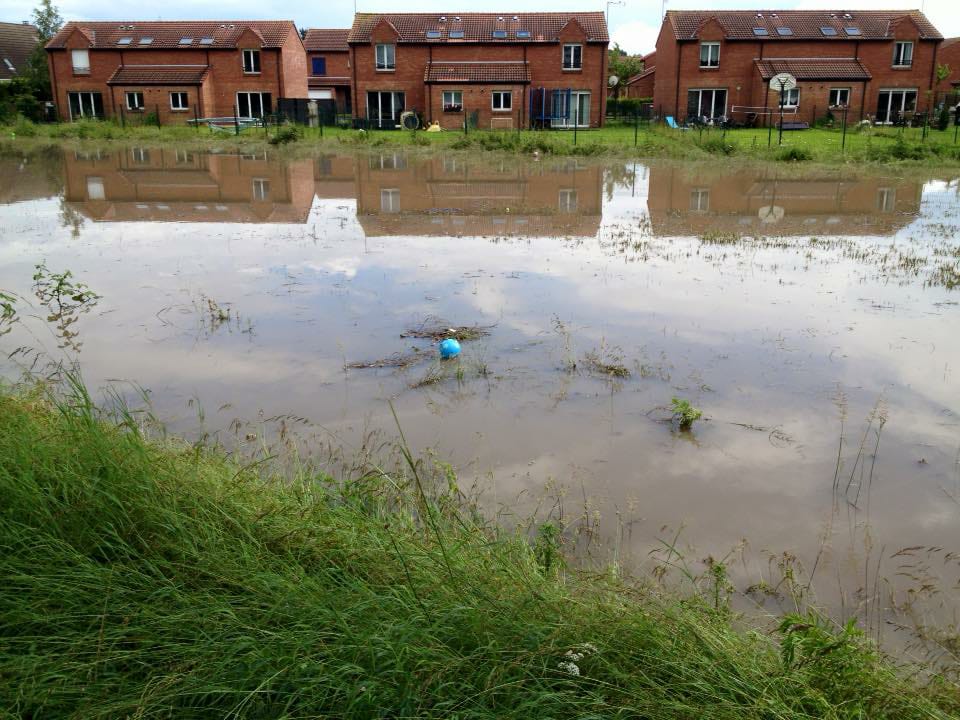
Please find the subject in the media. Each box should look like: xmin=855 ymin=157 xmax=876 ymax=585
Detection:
xmin=46 ymin=20 xmax=307 ymax=123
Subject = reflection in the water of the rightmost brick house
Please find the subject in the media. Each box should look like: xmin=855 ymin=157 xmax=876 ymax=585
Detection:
xmin=647 ymin=165 xmax=923 ymax=235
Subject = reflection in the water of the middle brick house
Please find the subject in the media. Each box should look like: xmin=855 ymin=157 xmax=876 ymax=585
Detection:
xmin=356 ymin=152 xmax=603 ymax=237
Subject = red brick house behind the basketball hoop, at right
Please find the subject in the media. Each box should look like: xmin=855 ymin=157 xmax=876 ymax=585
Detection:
xmin=654 ymin=10 xmax=943 ymax=123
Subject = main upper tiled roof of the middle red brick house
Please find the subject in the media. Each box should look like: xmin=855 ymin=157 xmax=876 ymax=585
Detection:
xmin=348 ymin=12 xmax=610 ymax=43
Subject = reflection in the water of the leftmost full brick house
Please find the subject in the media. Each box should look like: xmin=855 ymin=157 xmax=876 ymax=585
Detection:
xmin=64 ymin=148 xmax=313 ymax=223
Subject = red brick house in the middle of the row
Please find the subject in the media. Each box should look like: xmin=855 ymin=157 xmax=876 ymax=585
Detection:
xmin=348 ymin=12 xmax=609 ymax=129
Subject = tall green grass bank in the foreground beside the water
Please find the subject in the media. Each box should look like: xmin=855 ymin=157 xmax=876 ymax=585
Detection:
xmin=0 ymin=386 xmax=960 ymax=720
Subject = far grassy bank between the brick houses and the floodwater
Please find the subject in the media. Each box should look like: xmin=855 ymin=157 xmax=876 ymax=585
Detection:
xmin=0 ymin=115 xmax=960 ymax=167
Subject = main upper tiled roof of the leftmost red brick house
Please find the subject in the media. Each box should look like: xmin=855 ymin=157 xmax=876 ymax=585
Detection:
xmin=47 ymin=20 xmax=299 ymax=50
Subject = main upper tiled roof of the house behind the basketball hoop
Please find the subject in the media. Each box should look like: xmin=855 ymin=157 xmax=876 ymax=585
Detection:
xmin=667 ymin=10 xmax=943 ymax=41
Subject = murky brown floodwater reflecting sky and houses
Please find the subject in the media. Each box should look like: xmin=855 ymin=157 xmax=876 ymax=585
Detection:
xmin=0 ymin=148 xmax=960 ymax=648
